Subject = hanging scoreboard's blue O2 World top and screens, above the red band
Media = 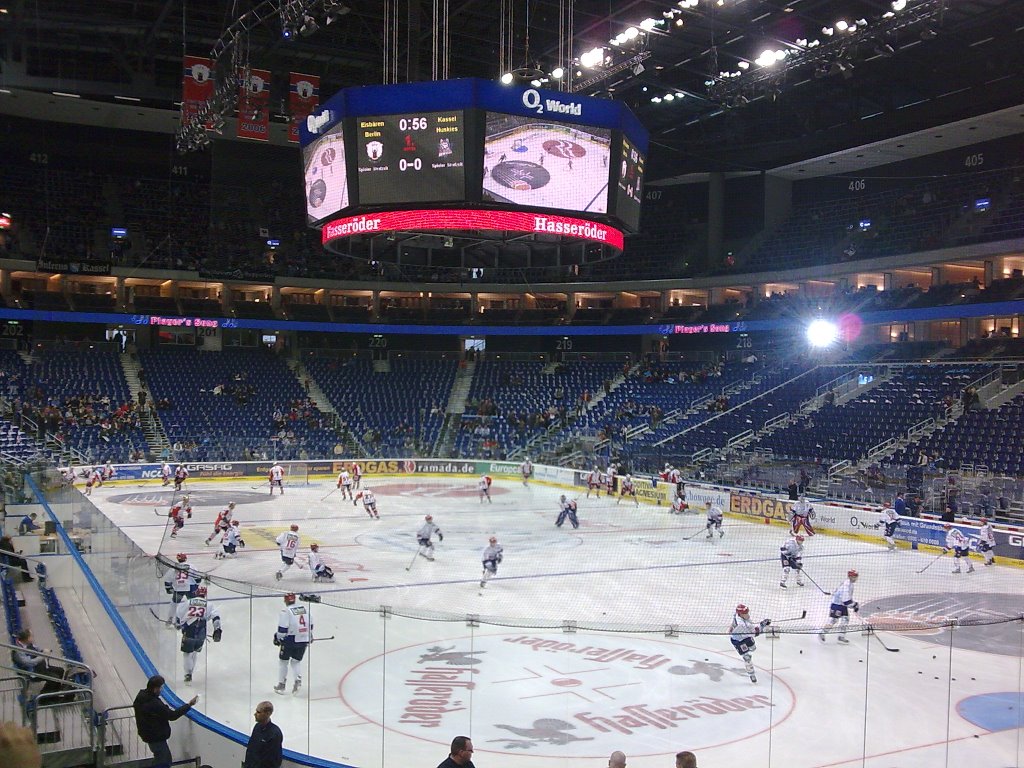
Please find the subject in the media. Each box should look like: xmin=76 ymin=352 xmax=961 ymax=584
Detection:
xmin=301 ymin=79 xmax=647 ymax=230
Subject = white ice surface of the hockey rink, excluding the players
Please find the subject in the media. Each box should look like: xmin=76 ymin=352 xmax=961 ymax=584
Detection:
xmin=79 ymin=475 xmax=1024 ymax=768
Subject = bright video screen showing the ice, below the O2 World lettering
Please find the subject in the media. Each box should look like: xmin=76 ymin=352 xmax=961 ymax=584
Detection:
xmin=482 ymin=112 xmax=611 ymax=214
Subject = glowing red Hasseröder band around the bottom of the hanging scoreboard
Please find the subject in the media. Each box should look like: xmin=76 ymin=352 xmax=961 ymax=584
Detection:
xmin=322 ymin=209 xmax=624 ymax=251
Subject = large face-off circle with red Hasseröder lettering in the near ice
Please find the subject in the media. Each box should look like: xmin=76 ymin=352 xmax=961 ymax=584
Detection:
xmin=341 ymin=630 xmax=795 ymax=760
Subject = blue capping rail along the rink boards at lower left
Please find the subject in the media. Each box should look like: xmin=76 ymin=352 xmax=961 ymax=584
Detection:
xmin=25 ymin=475 xmax=353 ymax=768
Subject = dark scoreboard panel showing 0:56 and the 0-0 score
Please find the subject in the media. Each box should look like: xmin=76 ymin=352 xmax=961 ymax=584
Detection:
xmin=355 ymin=110 xmax=466 ymax=206
